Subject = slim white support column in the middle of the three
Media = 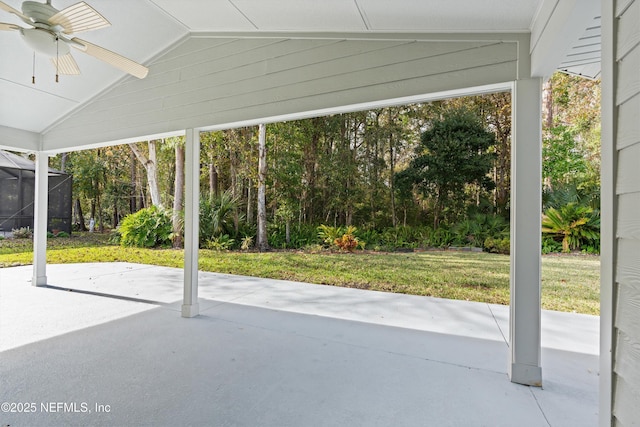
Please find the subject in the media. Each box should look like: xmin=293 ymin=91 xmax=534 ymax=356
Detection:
xmin=182 ymin=129 xmax=200 ymax=317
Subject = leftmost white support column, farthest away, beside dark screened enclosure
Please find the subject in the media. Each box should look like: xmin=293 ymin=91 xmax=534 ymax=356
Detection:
xmin=31 ymin=151 xmax=49 ymax=286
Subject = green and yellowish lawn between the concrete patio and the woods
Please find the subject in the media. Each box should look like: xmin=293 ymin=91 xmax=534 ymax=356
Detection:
xmin=0 ymin=233 xmax=600 ymax=314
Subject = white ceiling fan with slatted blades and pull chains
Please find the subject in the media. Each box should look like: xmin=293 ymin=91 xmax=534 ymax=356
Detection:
xmin=0 ymin=0 xmax=149 ymax=81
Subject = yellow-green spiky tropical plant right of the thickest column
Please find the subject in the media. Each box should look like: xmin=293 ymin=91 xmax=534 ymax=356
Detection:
xmin=542 ymin=203 xmax=600 ymax=252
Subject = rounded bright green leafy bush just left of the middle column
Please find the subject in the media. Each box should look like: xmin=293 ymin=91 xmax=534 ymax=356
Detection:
xmin=118 ymin=206 xmax=173 ymax=248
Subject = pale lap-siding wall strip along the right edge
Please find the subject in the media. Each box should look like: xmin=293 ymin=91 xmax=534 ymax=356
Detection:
xmin=612 ymin=0 xmax=640 ymax=426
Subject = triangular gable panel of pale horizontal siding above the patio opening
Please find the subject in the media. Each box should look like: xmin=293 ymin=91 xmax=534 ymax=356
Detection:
xmin=45 ymin=38 xmax=518 ymax=149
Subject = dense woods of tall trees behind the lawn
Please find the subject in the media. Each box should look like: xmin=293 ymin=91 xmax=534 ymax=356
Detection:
xmin=51 ymin=73 xmax=600 ymax=252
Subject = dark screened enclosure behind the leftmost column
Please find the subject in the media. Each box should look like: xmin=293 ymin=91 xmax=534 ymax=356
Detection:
xmin=0 ymin=150 xmax=72 ymax=234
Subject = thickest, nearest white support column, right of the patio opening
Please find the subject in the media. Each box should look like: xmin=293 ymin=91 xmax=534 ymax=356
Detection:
xmin=509 ymin=78 xmax=542 ymax=387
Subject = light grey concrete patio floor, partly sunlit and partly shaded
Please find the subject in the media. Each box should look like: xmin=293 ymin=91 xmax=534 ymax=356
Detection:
xmin=0 ymin=263 xmax=598 ymax=427
